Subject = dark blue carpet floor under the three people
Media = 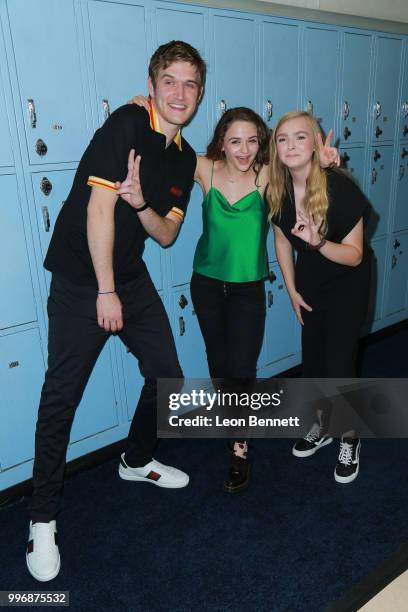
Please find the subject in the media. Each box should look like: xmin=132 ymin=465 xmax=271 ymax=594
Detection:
xmin=0 ymin=322 xmax=408 ymax=612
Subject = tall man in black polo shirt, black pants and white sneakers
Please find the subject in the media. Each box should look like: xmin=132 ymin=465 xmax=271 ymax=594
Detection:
xmin=26 ymin=41 xmax=205 ymax=581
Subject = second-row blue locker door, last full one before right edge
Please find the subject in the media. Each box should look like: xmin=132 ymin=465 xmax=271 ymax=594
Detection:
xmin=367 ymin=146 xmax=392 ymax=238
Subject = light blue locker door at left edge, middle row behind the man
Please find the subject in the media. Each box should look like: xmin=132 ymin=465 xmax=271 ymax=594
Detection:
xmin=0 ymin=174 xmax=37 ymax=329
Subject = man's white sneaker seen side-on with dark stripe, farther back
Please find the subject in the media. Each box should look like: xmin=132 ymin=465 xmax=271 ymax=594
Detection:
xmin=119 ymin=453 xmax=190 ymax=489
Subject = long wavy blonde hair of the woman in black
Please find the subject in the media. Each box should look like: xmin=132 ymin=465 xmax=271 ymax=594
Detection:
xmin=267 ymin=111 xmax=329 ymax=237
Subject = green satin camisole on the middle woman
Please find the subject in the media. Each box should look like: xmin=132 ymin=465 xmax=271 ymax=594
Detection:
xmin=193 ymin=165 xmax=269 ymax=283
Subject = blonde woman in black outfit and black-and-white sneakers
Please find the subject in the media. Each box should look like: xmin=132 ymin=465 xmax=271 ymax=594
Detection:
xmin=267 ymin=111 xmax=370 ymax=483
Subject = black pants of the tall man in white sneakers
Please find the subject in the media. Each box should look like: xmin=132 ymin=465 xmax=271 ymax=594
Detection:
xmin=31 ymin=272 xmax=182 ymax=522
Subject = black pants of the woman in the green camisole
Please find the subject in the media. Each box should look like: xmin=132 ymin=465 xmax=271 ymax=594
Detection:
xmin=191 ymin=272 xmax=265 ymax=444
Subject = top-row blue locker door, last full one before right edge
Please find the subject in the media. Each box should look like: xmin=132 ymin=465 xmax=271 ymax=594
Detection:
xmin=371 ymin=36 xmax=402 ymax=142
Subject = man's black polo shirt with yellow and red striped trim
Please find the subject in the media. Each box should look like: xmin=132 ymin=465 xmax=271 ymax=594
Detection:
xmin=44 ymin=104 xmax=196 ymax=286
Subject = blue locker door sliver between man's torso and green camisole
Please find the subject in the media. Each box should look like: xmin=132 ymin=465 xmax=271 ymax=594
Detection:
xmin=170 ymin=184 xmax=203 ymax=286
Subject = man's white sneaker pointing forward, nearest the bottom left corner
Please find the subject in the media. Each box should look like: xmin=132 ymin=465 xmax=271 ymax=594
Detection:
xmin=26 ymin=521 xmax=61 ymax=582
